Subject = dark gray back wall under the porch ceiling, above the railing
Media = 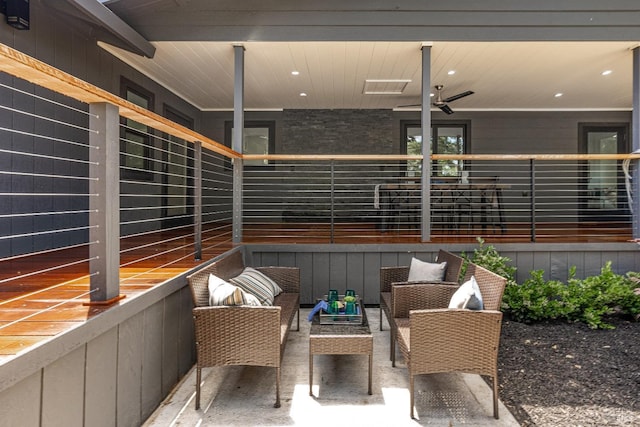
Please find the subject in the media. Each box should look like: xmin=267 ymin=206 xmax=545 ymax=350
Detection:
xmin=203 ymin=110 xmax=631 ymax=154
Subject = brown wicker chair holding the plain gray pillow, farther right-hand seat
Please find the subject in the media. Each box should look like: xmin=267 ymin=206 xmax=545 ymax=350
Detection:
xmin=380 ymin=249 xmax=463 ymax=360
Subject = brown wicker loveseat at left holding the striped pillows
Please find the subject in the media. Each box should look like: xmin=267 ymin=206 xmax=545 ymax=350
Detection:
xmin=187 ymin=249 xmax=300 ymax=409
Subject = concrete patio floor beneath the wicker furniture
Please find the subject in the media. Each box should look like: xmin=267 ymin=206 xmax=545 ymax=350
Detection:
xmin=144 ymin=307 xmax=519 ymax=427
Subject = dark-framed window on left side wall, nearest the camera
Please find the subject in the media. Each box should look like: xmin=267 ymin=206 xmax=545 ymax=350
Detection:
xmin=120 ymin=78 xmax=153 ymax=180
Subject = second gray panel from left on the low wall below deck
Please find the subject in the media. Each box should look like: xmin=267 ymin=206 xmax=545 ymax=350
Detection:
xmin=42 ymin=346 xmax=85 ymax=427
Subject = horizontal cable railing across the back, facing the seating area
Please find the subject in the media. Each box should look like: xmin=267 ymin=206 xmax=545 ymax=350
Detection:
xmin=243 ymin=154 xmax=635 ymax=243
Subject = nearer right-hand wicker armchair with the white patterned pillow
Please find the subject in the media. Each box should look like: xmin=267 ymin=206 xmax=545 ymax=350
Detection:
xmin=392 ymin=263 xmax=506 ymax=419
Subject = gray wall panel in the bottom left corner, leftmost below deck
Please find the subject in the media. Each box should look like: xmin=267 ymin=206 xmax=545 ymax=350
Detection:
xmin=0 ymin=370 xmax=42 ymax=427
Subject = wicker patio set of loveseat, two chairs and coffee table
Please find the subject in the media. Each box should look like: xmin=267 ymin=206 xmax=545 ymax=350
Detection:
xmin=187 ymin=250 xmax=506 ymax=419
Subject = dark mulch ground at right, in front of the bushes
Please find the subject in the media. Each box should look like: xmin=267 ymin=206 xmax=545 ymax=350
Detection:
xmin=498 ymin=319 xmax=640 ymax=427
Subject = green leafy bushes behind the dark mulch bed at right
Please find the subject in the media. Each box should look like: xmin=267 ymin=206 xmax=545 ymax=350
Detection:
xmin=462 ymin=238 xmax=640 ymax=329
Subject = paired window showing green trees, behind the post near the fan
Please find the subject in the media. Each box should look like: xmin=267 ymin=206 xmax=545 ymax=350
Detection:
xmin=402 ymin=122 xmax=468 ymax=176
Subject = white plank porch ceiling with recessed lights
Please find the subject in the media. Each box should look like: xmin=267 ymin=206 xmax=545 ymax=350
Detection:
xmin=101 ymin=42 xmax=637 ymax=111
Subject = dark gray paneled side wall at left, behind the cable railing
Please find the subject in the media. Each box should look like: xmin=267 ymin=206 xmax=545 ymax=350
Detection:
xmin=0 ymin=2 xmax=201 ymax=257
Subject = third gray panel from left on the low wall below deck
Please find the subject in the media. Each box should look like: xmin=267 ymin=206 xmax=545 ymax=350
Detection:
xmin=84 ymin=328 xmax=118 ymax=427
